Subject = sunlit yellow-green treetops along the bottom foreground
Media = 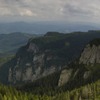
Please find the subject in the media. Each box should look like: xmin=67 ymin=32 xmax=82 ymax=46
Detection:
xmin=0 ymin=80 xmax=100 ymax=100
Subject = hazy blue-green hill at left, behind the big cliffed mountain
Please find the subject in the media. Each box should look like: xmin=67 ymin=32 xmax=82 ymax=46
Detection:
xmin=0 ymin=32 xmax=36 ymax=56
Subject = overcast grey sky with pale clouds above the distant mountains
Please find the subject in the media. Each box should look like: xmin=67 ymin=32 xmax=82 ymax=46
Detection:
xmin=0 ymin=0 xmax=100 ymax=23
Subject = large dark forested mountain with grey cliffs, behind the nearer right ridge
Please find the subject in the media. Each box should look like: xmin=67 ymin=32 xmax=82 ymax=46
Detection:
xmin=0 ymin=31 xmax=100 ymax=85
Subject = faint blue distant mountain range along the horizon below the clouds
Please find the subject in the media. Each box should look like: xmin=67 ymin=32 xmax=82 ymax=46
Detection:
xmin=0 ymin=22 xmax=100 ymax=34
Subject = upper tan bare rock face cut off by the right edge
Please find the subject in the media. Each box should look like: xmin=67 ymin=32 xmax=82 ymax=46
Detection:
xmin=79 ymin=44 xmax=100 ymax=65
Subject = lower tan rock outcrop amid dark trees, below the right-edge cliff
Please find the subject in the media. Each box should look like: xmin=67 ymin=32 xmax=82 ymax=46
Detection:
xmin=58 ymin=68 xmax=91 ymax=86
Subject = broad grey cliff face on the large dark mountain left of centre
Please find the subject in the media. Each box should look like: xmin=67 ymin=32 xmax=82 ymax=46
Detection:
xmin=8 ymin=42 xmax=61 ymax=84
